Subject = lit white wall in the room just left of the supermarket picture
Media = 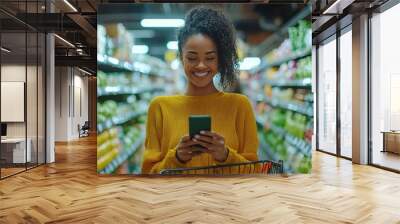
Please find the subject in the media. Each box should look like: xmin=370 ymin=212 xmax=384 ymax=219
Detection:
xmin=55 ymin=67 xmax=89 ymax=141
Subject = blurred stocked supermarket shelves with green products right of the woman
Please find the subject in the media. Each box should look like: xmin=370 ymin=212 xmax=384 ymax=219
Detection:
xmin=245 ymin=21 xmax=314 ymax=173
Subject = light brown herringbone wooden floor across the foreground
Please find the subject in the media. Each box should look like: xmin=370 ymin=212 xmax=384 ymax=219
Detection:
xmin=0 ymin=137 xmax=400 ymax=224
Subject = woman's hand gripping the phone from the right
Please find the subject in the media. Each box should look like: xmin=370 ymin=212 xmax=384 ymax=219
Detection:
xmin=193 ymin=131 xmax=229 ymax=162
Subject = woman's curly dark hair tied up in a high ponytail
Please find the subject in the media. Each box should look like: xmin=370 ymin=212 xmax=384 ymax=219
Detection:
xmin=178 ymin=7 xmax=238 ymax=89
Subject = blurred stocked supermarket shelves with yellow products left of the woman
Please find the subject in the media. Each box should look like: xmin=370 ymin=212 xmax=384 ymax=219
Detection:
xmin=97 ymin=24 xmax=175 ymax=174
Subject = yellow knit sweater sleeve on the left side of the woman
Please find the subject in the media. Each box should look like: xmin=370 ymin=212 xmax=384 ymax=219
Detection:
xmin=142 ymin=98 xmax=185 ymax=174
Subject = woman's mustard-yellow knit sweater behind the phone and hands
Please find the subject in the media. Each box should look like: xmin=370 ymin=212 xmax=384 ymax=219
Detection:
xmin=142 ymin=92 xmax=258 ymax=174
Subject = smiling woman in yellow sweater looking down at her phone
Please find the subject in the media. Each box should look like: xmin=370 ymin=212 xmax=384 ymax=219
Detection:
xmin=142 ymin=8 xmax=258 ymax=173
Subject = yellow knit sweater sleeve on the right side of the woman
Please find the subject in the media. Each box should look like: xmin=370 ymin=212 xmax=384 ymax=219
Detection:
xmin=218 ymin=96 xmax=259 ymax=164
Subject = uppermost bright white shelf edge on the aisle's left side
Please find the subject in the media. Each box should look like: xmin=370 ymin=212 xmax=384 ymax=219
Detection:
xmin=97 ymin=54 xmax=133 ymax=72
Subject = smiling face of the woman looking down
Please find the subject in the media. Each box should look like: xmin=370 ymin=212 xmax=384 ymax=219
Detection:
xmin=182 ymin=34 xmax=218 ymax=88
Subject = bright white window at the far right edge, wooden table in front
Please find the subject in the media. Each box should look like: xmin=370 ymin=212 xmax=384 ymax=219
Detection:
xmin=370 ymin=4 xmax=400 ymax=170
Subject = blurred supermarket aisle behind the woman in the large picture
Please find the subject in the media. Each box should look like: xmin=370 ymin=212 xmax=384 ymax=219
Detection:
xmin=97 ymin=4 xmax=314 ymax=173
